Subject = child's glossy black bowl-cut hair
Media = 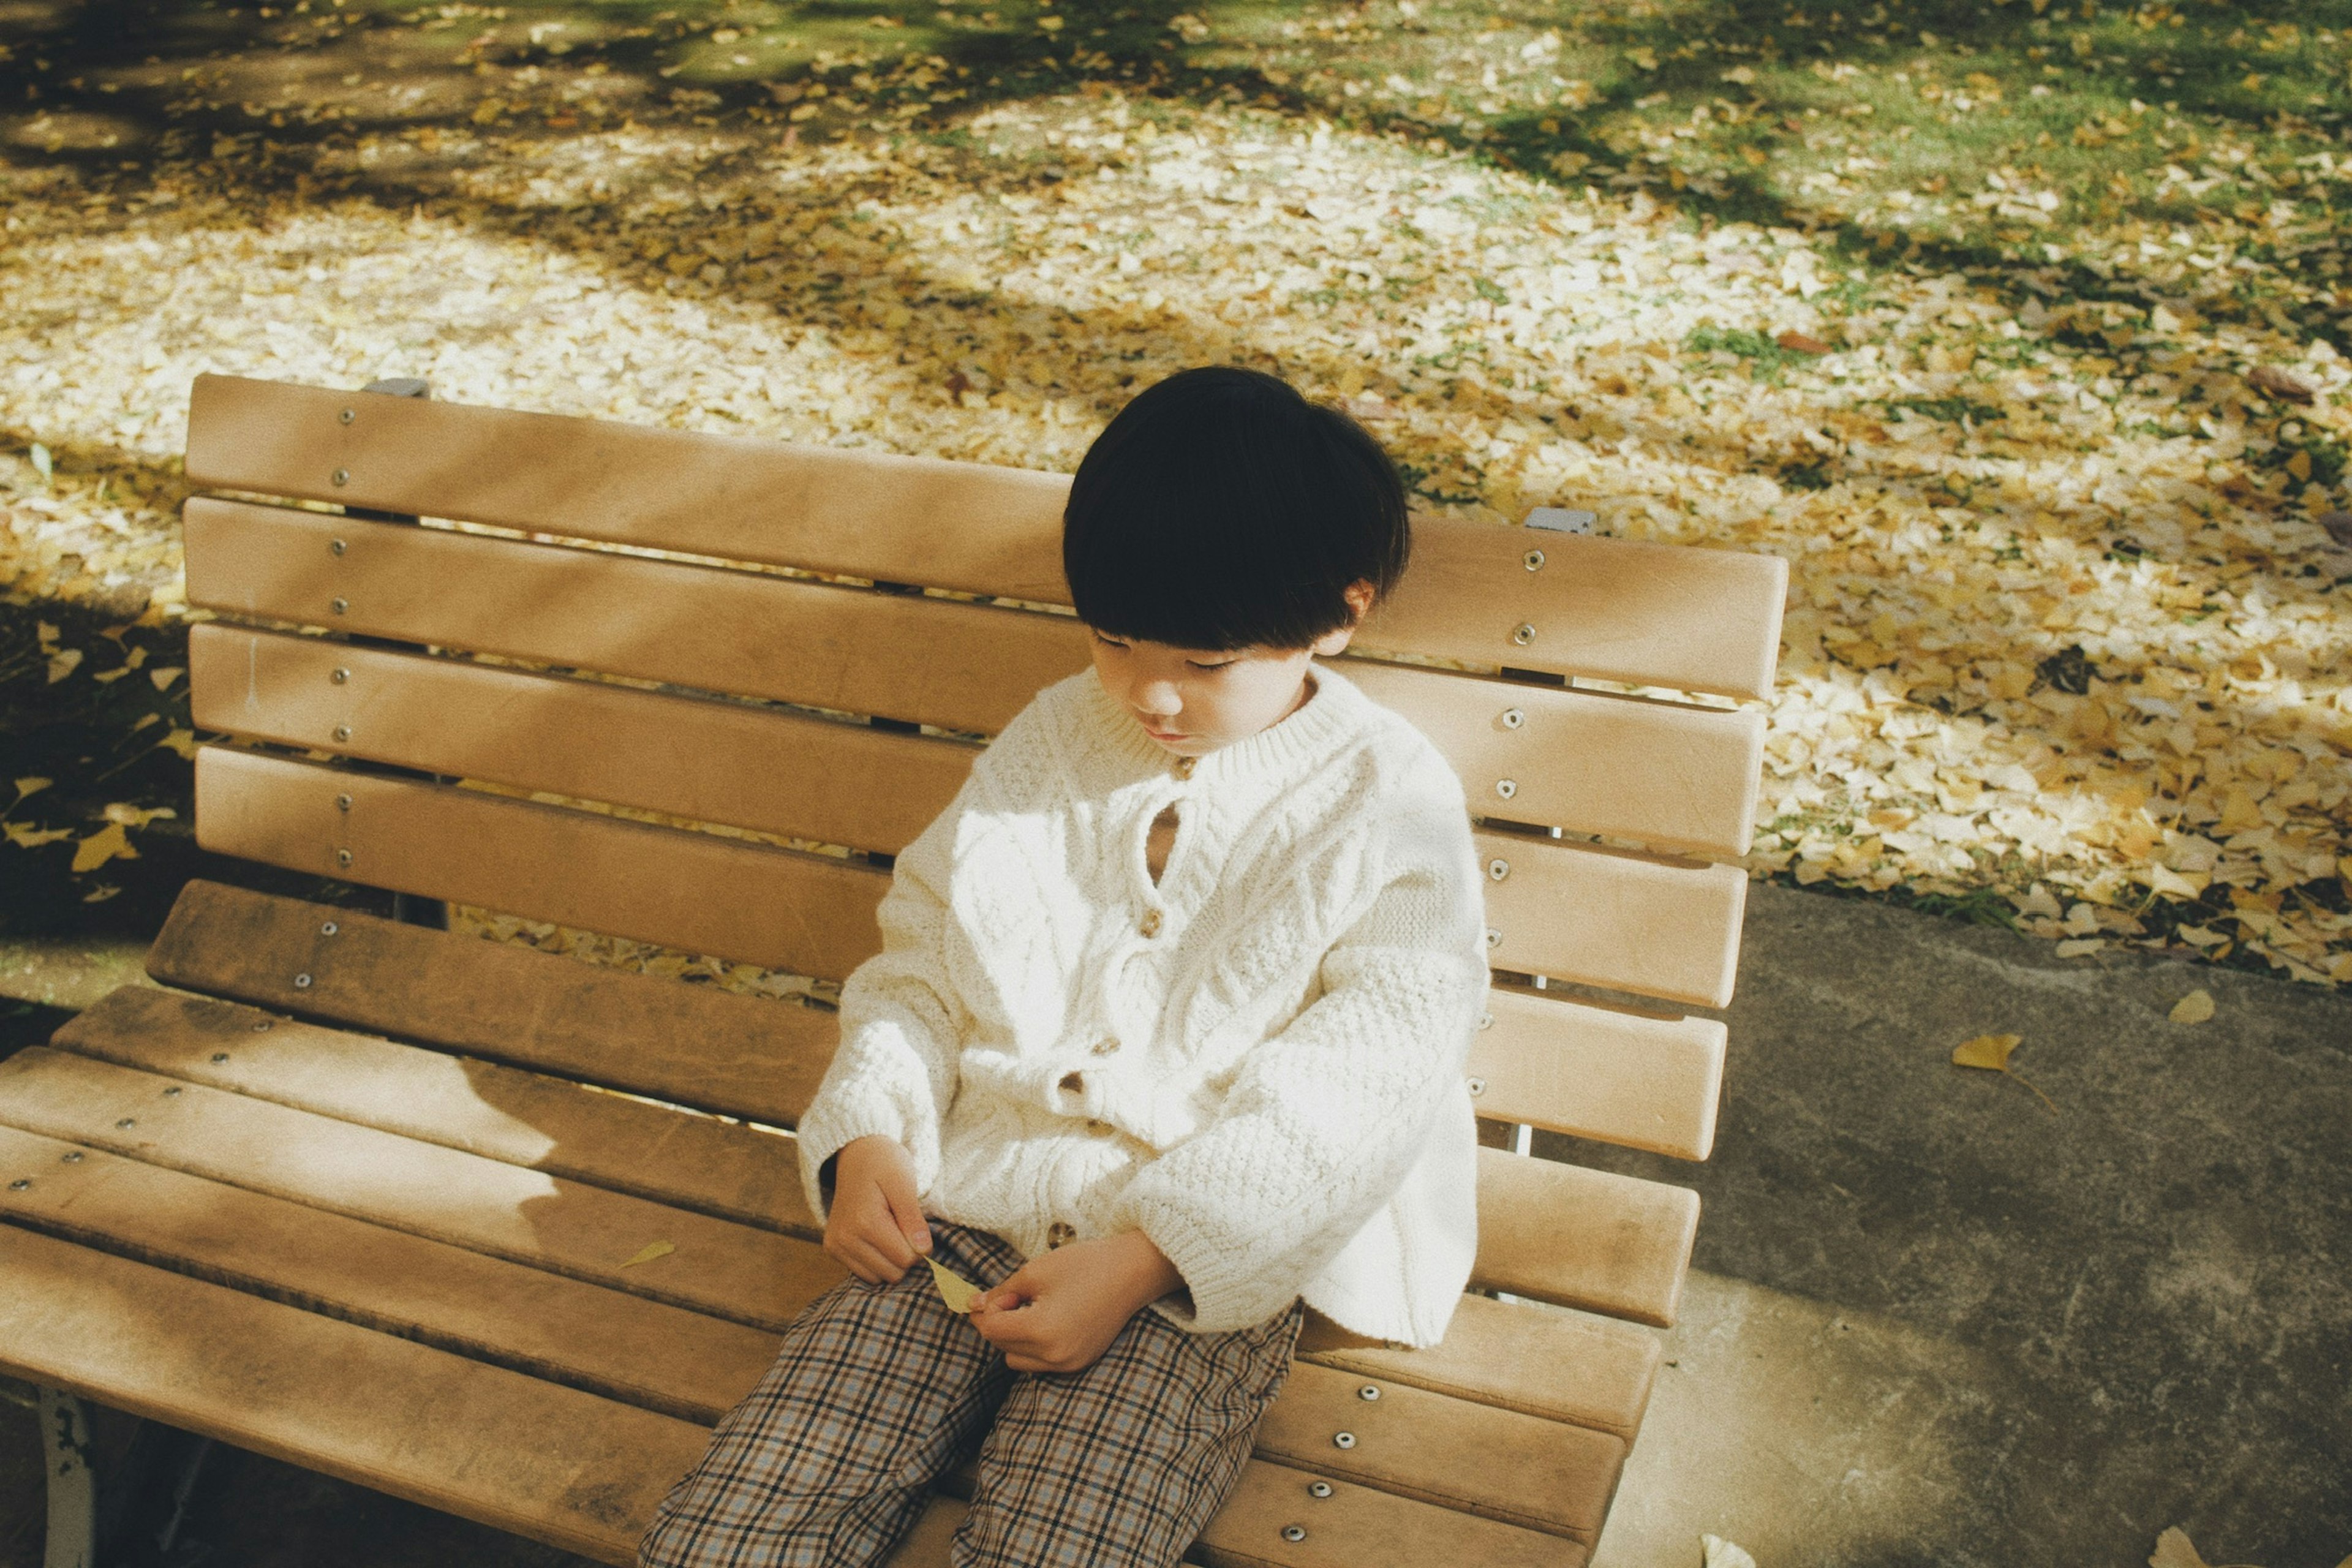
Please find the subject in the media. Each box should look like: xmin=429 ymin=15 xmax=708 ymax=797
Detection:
xmin=1061 ymin=367 xmax=1411 ymax=651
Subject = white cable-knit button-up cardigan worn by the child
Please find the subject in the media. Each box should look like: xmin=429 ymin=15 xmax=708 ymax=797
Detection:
xmin=797 ymin=668 xmax=1487 ymax=1347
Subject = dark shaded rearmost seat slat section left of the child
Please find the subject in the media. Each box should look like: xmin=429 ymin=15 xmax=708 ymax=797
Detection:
xmin=142 ymin=879 xmax=840 ymax=1126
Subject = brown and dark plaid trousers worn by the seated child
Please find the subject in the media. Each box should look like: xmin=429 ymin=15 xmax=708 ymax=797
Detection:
xmin=638 ymin=1220 xmax=1305 ymax=1568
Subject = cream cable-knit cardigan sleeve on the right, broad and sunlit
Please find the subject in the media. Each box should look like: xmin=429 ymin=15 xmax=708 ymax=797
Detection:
xmin=1117 ymin=776 xmax=1487 ymax=1333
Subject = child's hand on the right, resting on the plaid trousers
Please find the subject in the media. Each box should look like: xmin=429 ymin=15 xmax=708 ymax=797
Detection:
xmin=971 ymin=1229 xmax=1183 ymax=1373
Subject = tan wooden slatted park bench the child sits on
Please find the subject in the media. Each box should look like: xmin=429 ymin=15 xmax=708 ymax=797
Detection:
xmin=0 ymin=376 xmax=1785 ymax=1568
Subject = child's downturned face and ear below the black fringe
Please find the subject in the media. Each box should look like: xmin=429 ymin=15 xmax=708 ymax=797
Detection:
xmin=1094 ymin=583 xmax=1371 ymax=757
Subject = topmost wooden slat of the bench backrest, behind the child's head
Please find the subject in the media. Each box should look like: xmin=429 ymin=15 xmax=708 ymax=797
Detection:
xmin=188 ymin=376 xmax=1787 ymax=696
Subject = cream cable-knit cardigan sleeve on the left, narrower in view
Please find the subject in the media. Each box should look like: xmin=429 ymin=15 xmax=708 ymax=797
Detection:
xmin=795 ymin=780 xmax=971 ymax=1223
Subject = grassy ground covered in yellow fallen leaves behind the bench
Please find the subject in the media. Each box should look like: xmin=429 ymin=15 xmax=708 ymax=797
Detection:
xmin=0 ymin=0 xmax=2352 ymax=982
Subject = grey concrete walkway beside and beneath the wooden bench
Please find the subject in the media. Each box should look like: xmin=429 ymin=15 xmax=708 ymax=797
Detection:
xmin=0 ymin=886 xmax=2352 ymax=1568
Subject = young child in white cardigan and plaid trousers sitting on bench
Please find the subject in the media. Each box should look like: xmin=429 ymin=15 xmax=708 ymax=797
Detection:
xmin=639 ymin=369 xmax=1487 ymax=1568
